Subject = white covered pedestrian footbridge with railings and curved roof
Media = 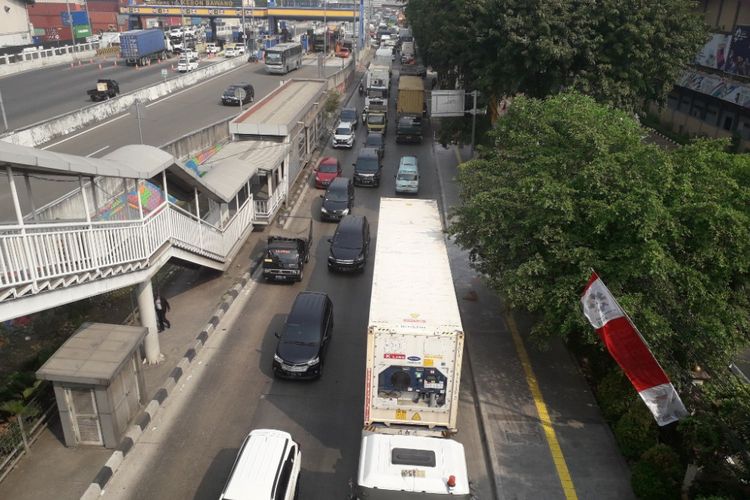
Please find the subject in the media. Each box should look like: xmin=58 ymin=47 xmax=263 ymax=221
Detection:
xmin=0 ymin=142 xmax=286 ymax=320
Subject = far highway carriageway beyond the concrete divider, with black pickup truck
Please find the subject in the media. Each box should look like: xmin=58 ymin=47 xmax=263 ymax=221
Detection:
xmin=0 ymin=53 xmax=232 ymax=130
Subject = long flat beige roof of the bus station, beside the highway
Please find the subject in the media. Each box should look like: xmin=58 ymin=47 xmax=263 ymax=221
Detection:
xmin=229 ymin=79 xmax=326 ymax=137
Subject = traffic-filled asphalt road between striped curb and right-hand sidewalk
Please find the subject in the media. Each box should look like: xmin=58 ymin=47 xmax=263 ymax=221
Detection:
xmin=100 ymin=75 xmax=500 ymax=500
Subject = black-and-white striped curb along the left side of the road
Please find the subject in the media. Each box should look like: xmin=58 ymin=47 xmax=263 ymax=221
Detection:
xmin=81 ymin=259 xmax=261 ymax=500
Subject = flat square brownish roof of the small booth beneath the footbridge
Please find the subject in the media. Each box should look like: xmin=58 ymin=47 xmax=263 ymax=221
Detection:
xmin=36 ymin=323 xmax=148 ymax=386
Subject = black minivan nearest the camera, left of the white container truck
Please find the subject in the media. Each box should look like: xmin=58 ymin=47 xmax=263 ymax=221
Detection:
xmin=273 ymin=292 xmax=333 ymax=378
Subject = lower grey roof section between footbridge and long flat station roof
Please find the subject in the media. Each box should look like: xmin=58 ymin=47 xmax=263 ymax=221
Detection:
xmin=202 ymin=141 xmax=288 ymax=201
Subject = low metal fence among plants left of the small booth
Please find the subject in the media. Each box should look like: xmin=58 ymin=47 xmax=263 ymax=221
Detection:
xmin=0 ymin=382 xmax=56 ymax=481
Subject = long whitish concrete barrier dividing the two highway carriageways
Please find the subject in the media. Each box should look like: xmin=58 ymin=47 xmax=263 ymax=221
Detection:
xmin=2 ymin=57 xmax=247 ymax=147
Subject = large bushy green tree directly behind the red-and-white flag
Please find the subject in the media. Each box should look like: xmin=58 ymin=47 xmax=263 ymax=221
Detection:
xmin=450 ymin=93 xmax=750 ymax=383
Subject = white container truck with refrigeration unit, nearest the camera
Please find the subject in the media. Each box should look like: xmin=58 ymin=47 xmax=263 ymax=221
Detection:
xmin=352 ymin=198 xmax=471 ymax=500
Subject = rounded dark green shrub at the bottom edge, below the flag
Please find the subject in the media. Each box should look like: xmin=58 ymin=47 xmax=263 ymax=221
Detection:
xmin=630 ymin=444 xmax=682 ymax=500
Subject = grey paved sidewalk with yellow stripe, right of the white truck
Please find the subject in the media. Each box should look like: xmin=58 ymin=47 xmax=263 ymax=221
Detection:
xmin=434 ymin=144 xmax=634 ymax=500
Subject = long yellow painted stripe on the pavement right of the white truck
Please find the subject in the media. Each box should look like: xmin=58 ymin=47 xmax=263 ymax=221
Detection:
xmin=504 ymin=309 xmax=578 ymax=500
